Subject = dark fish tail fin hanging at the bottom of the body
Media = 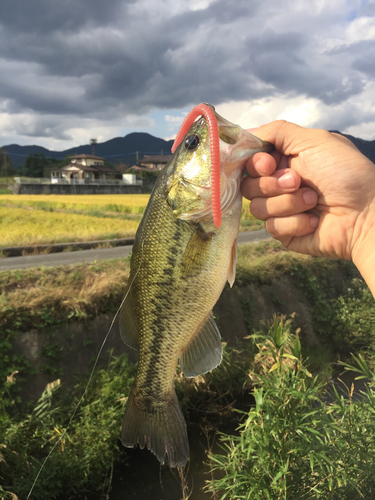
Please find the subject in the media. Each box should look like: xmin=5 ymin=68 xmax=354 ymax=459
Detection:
xmin=121 ymin=393 xmax=189 ymax=467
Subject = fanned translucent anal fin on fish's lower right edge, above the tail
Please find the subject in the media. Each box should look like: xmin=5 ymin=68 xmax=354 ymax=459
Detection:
xmin=180 ymin=312 xmax=223 ymax=377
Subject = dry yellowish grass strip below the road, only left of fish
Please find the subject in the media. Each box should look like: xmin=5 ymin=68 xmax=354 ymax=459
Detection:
xmin=0 ymin=259 xmax=129 ymax=327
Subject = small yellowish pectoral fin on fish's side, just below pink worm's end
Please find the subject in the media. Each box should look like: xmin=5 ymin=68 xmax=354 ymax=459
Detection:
xmin=181 ymin=225 xmax=214 ymax=277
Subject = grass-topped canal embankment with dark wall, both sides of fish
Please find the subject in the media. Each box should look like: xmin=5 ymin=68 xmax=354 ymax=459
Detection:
xmin=0 ymin=239 xmax=370 ymax=402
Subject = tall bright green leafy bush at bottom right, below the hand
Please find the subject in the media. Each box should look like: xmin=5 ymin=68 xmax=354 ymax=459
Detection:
xmin=209 ymin=320 xmax=375 ymax=500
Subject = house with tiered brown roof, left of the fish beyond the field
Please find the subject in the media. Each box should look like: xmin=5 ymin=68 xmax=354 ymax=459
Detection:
xmin=51 ymin=154 xmax=121 ymax=183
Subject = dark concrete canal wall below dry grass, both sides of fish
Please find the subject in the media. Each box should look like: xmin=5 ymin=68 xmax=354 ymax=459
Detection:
xmin=13 ymin=276 xmax=319 ymax=399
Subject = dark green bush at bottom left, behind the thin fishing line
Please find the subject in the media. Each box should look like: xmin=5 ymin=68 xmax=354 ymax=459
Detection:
xmin=0 ymin=356 xmax=135 ymax=500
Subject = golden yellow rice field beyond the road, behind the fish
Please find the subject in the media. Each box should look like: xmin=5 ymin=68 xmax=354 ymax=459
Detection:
xmin=0 ymin=194 xmax=265 ymax=251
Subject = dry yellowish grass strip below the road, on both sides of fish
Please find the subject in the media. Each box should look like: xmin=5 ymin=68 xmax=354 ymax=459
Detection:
xmin=0 ymin=242 xmax=349 ymax=328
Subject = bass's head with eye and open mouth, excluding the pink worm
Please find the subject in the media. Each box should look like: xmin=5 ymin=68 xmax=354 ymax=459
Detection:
xmin=166 ymin=106 xmax=274 ymax=221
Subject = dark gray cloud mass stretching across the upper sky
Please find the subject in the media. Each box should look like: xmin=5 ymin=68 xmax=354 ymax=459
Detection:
xmin=0 ymin=0 xmax=375 ymax=144
